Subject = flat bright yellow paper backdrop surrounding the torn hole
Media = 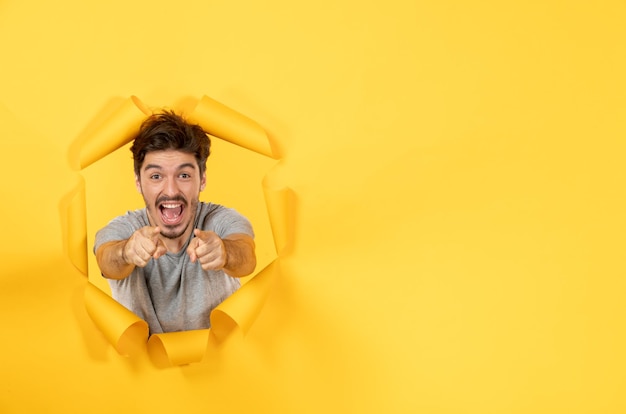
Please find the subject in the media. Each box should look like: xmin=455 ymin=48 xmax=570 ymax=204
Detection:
xmin=0 ymin=0 xmax=626 ymax=414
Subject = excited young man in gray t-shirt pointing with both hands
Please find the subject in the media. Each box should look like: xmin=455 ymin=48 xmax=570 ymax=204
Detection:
xmin=94 ymin=111 xmax=256 ymax=333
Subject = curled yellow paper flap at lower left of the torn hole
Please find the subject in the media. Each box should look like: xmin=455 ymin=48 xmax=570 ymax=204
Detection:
xmin=85 ymin=283 xmax=149 ymax=355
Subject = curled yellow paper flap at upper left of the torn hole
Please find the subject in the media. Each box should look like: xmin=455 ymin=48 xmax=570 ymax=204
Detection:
xmin=79 ymin=97 xmax=147 ymax=169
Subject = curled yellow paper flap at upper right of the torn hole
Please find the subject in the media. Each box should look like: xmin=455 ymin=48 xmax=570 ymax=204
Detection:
xmin=187 ymin=96 xmax=276 ymax=159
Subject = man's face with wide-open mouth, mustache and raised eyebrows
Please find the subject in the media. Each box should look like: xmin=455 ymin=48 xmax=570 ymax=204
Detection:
xmin=135 ymin=150 xmax=206 ymax=240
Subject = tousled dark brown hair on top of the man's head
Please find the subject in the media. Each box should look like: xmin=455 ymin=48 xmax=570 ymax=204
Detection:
xmin=130 ymin=110 xmax=211 ymax=176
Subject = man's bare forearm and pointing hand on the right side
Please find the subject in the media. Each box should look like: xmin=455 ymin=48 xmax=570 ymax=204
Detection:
xmin=187 ymin=229 xmax=256 ymax=277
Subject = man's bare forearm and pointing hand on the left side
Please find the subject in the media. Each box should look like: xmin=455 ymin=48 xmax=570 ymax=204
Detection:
xmin=96 ymin=226 xmax=167 ymax=279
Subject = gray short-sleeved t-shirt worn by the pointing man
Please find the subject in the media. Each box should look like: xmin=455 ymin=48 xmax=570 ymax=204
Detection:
xmin=94 ymin=202 xmax=254 ymax=333
